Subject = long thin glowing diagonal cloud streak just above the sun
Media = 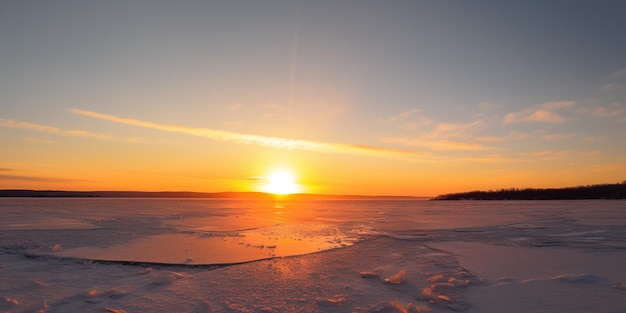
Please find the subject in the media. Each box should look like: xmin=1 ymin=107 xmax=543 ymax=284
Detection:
xmin=68 ymin=109 xmax=426 ymax=157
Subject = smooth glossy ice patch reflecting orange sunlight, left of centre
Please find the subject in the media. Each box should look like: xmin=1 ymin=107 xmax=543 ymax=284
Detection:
xmin=47 ymin=224 xmax=356 ymax=265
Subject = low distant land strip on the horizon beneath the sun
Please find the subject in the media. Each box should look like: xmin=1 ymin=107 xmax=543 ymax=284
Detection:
xmin=0 ymin=189 xmax=430 ymax=200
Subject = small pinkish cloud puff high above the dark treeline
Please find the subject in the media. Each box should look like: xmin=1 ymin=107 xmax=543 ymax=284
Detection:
xmin=504 ymin=101 xmax=574 ymax=124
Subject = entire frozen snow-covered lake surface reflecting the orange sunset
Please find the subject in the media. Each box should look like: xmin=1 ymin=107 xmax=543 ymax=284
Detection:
xmin=0 ymin=198 xmax=626 ymax=313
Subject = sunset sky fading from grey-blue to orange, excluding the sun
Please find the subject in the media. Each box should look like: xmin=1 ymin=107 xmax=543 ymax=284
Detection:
xmin=0 ymin=0 xmax=626 ymax=196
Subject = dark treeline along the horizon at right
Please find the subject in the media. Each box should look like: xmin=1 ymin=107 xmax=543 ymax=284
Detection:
xmin=433 ymin=181 xmax=626 ymax=200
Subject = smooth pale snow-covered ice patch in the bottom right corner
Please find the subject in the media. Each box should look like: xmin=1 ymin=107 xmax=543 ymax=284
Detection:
xmin=430 ymin=242 xmax=626 ymax=313
